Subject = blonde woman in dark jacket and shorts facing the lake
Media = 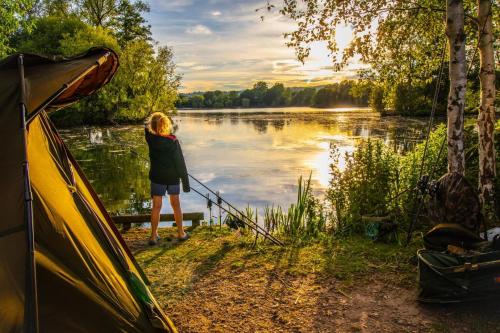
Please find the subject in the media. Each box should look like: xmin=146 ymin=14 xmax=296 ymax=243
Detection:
xmin=145 ymin=112 xmax=190 ymax=245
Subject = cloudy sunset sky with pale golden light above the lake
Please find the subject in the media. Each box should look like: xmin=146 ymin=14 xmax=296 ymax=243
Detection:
xmin=146 ymin=0 xmax=363 ymax=92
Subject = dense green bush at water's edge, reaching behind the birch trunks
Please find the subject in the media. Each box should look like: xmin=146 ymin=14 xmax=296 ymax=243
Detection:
xmin=326 ymin=121 xmax=500 ymax=234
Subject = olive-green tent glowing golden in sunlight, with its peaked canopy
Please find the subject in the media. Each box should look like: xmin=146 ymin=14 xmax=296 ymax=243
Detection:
xmin=0 ymin=48 xmax=176 ymax=332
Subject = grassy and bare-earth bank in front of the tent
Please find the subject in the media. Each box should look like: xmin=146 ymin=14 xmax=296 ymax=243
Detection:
xmin=124 ymin=227 xmax=500 ymax=332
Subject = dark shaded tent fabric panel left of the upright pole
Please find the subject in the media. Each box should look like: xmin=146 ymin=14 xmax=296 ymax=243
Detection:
xmin=0 ymin=49 xmax=28 ymax=332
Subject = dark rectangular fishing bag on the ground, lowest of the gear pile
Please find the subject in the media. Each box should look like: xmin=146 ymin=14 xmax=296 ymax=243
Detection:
xmin=417 ymin=248 xmax=500 ymax=303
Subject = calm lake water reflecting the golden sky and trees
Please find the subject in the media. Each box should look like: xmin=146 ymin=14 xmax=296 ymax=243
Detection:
xmin=60 ymin=108 xmax=434 ymax=220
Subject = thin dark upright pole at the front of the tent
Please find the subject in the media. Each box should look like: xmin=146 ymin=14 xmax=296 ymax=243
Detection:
xmin=18 ymin=54 xmax=38 ymax=333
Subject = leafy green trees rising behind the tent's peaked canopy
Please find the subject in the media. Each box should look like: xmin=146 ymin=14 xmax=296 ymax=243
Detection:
xmin=4 ymin=0 xmax=180 ymax=125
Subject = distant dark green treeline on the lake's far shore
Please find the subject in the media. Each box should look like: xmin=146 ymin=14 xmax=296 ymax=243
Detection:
xmin=176 ymin=80 xmax=371 ymax=109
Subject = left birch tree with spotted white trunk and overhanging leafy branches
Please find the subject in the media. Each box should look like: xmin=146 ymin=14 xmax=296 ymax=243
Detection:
xmin=281 ymin=0 xmax=474 ymax=164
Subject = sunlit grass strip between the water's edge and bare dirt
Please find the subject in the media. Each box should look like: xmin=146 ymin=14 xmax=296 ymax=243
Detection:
xmin=127 ymin=227 xmax=419 ymax=304
